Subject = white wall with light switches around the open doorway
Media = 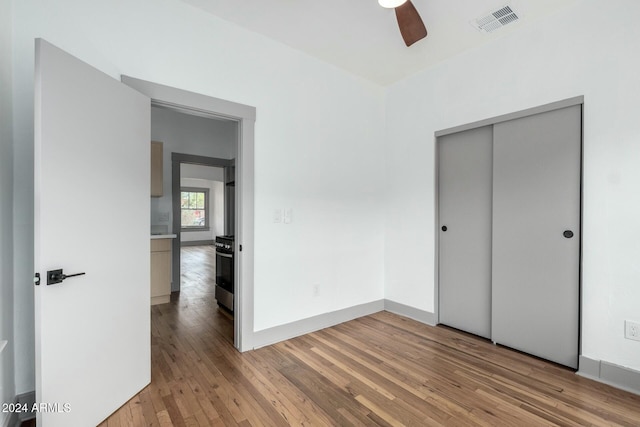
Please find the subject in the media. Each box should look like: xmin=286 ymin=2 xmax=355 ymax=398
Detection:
xmin=13 ymin=0 xmax=384 ymax=389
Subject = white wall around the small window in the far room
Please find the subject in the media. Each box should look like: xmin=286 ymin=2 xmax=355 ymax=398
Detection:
xmin=180 ymin=173 xmax=224 ymax=242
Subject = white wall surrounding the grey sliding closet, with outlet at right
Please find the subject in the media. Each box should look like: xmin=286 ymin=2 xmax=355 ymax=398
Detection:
xmin=385 ymin=0 xmax=640 ymax=369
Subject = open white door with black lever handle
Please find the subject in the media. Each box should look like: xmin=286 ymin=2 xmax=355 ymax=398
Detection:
xmin=34 ymin=40 xmax=151 ymax=427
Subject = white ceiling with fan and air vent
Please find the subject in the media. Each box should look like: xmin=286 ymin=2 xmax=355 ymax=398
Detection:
xmin=182 ymin=0 xmax=576 ymax=85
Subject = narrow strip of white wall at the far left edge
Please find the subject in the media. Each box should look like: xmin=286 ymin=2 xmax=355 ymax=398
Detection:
xmin=0 ymin=0 xmax=15 ymax=414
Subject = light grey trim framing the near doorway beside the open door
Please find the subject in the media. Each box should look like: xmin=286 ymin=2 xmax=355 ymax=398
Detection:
xmin=121 ymin=75 xmax=256 ymax=351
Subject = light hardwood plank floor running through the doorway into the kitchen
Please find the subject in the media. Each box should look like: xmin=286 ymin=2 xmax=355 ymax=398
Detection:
xmin=101 ymin=247 xmax=640 ymax=427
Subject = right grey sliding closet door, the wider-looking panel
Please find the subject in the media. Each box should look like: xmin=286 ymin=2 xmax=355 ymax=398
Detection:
xmin=491 ymin=105 xmax=582 ymax=368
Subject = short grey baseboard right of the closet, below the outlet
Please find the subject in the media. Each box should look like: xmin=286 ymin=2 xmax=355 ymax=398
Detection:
xmin=577 ymin=356 xmax=640 ymax=395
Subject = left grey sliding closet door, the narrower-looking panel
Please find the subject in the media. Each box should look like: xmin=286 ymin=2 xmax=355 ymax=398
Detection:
xmin=437 ymin=126 xmax=492 ymax=338
